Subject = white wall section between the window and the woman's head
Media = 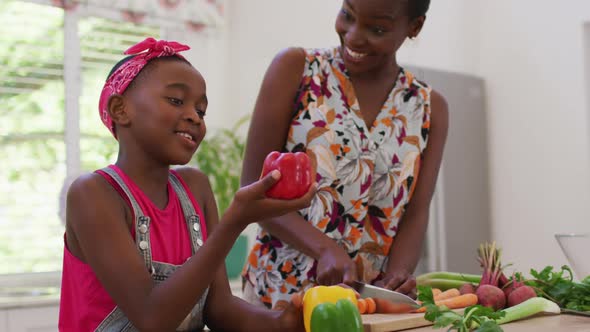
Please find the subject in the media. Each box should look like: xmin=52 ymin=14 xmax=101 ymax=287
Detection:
xmin=228 ymin=0 xmax=341 ymax=122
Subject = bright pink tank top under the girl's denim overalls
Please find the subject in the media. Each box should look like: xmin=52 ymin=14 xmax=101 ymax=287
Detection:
xmin=59 ymin=165 xmax=207 ymax=332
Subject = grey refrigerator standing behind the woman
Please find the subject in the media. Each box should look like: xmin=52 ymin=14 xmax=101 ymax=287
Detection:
xmin=406 ymin=66 xmax=491 ymax=274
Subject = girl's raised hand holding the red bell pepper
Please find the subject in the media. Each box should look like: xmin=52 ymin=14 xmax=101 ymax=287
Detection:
xmin=227 ymin=170 xmax=317 ymax=225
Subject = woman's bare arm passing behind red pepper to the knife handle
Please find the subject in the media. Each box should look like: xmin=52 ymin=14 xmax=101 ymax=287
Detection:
xmin=241 ymin=48 xmax=356 ymax=284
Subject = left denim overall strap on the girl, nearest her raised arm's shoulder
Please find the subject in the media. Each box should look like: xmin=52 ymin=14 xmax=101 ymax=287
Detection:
xmin=101 ymin=167 xmax=154 ymax=274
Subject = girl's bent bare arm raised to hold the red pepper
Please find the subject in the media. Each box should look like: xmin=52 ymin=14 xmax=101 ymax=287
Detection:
xmin=67 ymin=172 xmax=313 ymax=331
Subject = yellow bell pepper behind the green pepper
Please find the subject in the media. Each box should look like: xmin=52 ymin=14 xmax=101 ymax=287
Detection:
xmin=303 ymin=286 xmax=362 ymax=332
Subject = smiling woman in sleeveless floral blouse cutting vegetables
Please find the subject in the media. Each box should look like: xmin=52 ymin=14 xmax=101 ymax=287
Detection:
xmin=242 ymin=0 xmax=448 ymax=307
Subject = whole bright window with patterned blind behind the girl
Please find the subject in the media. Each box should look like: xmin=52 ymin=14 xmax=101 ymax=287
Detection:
xmin=0 ymin=0 xmax=228 ymax=283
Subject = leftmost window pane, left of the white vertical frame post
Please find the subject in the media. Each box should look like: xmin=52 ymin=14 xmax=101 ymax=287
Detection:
xmin=0 ymin=1 xmax=65 ymax=273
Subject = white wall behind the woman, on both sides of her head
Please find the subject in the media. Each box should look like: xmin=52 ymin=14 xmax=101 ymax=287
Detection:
xmin=226 ymin=0 xmax=590 ymax=271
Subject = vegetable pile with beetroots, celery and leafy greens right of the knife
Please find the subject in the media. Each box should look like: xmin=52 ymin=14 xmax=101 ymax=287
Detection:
xmin=416 ymin=243 xmax=590 ymax=332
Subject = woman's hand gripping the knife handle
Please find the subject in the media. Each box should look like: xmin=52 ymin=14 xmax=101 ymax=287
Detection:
xmin=316 ymin=246 xmax=358 ymax=285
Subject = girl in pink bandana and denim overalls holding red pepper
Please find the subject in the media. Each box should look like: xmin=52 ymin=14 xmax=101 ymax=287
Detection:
xmin=59 ymin=38 xmax=315 ymax=331
